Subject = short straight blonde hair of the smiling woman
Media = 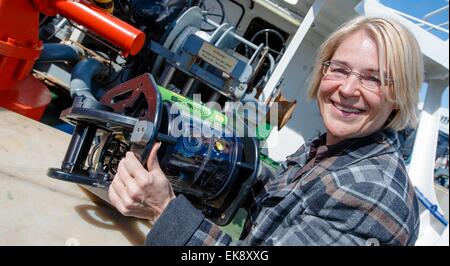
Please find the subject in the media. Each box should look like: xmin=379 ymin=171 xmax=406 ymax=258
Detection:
xmin=308 ymin=16 xmax=424 ymax=131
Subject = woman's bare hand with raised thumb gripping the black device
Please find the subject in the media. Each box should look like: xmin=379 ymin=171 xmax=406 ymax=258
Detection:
xmin=109 ymin=143 xmax=175 ymax=221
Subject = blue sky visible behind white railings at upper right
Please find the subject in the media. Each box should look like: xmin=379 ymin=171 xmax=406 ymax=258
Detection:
xmin=379 ymin=0 xmax=449 ymax=108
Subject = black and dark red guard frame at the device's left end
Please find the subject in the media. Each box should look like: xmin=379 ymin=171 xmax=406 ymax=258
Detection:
xmin=47 ymin=73 xmax=162 ymax=187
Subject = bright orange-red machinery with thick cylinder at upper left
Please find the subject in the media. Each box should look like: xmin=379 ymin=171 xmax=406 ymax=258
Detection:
xmin=0 ymin=0 xmax=145 ymax=120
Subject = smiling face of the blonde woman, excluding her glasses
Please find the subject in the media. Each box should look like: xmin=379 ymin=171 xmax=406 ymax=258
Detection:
xmin=317 ymin=31 xmax=394 ymax=145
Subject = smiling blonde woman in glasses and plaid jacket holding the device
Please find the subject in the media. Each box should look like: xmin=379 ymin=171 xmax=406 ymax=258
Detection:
xmin=109 ymin=17 xmax=423 ymax=245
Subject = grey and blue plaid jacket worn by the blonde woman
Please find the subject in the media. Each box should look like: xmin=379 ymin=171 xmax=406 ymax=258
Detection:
xmin=146 ymin=130 xmax=419 ymax=245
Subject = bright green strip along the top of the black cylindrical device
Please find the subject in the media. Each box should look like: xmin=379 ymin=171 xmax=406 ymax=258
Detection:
xmin=158 ymin=86 xmax=227 ymax=126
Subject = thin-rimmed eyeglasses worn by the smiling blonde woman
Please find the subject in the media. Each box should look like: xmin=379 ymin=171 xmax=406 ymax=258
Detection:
xmin=322 ymin=60 xmax=393 ymax=93
